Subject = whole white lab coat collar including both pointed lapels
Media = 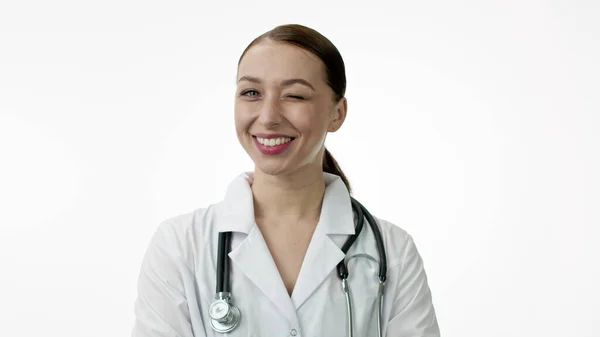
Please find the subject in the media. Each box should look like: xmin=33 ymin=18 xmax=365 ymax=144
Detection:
xmin=216 ymin=172 xmax=354 ymax=325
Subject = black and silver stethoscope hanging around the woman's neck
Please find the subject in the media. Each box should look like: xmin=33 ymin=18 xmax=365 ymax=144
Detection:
xmin=208 ymin=197 xmax=387 ymax=337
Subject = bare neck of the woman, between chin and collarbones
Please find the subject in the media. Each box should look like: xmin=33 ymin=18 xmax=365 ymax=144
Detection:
xmin=252 ymin=168 xmax=325 ymax=222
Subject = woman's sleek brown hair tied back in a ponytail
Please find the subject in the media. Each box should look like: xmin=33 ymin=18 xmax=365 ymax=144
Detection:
xmin=238 ymin=24 xmax=352 ymax=193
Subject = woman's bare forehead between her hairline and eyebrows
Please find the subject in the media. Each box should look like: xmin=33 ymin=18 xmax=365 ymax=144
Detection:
xmin=238 ymin=41 xmax=324 ymax=85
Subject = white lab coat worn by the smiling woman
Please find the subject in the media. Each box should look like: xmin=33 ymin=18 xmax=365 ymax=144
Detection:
xmin=132 ymin=172 xmax=440 ymax=337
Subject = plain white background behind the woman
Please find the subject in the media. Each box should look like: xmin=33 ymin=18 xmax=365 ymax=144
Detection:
xmin=0 ymin=0 xmax=600 ymax=337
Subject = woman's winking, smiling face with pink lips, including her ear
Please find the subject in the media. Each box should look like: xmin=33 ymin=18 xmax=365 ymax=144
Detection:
xmin=235 ymin=40 xmax=347 ymax=175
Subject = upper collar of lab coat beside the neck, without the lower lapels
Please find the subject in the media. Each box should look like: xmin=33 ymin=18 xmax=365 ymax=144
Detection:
xmin=217 ymin=172 xmax=355 ymax=235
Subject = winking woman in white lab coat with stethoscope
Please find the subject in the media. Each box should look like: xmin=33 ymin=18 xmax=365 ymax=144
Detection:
xmin=133 ymin=25 xmax=439 ymax=337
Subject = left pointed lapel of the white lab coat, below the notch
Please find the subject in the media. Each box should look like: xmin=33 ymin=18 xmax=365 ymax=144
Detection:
xmin=229 ymin=226 xmax=296 ymax=324
